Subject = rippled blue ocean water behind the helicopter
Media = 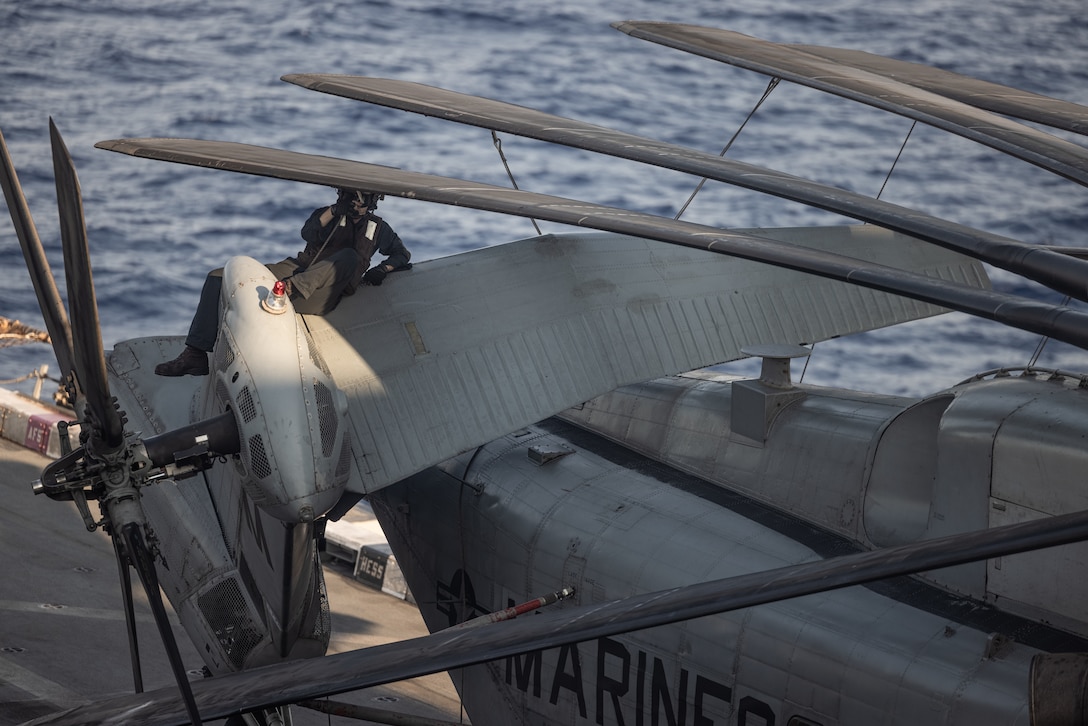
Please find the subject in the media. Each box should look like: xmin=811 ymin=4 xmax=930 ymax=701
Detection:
xmin=0 ymin=0 xmax=1088 ymax=395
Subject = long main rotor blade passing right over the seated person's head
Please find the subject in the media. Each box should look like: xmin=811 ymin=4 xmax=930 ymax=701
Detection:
xmin=96 ymin=138 xmax=1088 ymax=347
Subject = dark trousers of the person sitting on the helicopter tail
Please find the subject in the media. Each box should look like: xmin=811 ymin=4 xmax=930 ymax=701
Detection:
xmin=185 ymin=249 xmax=359 ymax=352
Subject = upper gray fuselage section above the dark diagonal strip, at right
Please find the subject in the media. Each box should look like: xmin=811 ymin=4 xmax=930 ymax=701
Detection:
xmin=562 ymin=371 xmax=1088 ymax=637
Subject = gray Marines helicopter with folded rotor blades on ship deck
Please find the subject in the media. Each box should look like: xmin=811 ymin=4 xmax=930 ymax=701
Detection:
xmin=2 ymin=22 xmax=1088 ymax=726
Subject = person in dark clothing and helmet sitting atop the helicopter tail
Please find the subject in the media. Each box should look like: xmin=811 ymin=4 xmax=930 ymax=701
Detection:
xmin=154 ymin=189 xmax=411 ymax=376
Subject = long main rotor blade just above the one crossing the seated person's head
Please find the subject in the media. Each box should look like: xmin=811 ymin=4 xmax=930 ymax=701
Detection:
xmin=274 ymin=74 xmax=1088 ymax=300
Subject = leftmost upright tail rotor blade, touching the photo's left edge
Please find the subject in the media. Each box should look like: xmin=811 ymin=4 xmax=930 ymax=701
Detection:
xmin=0 ymin=127 xmax=73 ymax=379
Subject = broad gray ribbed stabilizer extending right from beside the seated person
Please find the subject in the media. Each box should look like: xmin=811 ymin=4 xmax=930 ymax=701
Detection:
xmin=306 ymin=225 xmax=987 ymax=491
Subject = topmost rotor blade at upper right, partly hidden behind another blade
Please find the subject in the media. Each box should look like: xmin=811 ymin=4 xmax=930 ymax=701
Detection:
xmin=789 ymin=44 xmax=1088 ymax=134
